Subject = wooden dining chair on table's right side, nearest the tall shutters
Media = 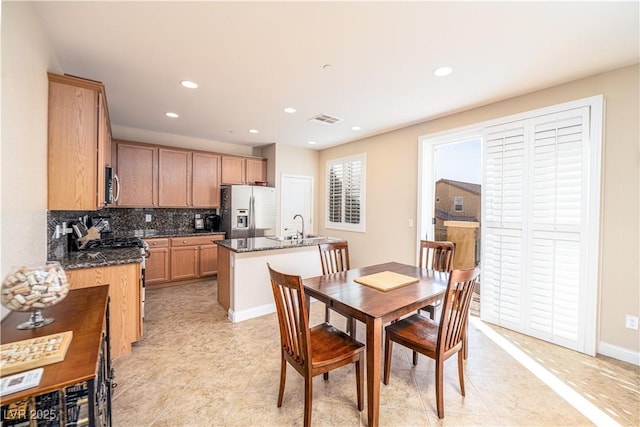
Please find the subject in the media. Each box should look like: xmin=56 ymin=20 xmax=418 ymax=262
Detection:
xmin=383 ymin=268 xmax=480 ymax=418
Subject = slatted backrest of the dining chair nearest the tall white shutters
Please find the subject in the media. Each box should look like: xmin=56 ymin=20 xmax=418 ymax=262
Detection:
xmin=436 ymin=268 xmax=480 ymax=354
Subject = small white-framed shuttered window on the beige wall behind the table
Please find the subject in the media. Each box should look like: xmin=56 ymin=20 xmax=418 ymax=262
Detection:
xmin=326 ymin=153 xmax=366 ymax=232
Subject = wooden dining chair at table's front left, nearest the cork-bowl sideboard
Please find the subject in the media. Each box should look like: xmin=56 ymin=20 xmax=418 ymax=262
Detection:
xmin=267 ymin=264 xmax=365 ymax=427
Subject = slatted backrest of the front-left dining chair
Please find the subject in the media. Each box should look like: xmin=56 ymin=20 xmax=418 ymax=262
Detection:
xmin=267 ymin=264 xmax=311 ymax=371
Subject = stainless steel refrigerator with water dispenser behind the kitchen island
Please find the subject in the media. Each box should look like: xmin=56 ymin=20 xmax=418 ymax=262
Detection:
xmin=220 ymin=185 xmax=276 ymax=239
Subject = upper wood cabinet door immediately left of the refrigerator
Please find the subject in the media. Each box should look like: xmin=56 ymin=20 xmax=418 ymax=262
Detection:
xmin=191 ymin=153 xmax=220 ymax=208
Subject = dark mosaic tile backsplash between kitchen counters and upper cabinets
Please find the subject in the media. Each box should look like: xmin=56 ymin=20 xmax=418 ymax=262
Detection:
xmin=47 ymin=208 xmax=216 ymax=259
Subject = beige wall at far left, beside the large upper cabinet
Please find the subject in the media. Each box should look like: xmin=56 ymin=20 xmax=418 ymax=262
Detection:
xmin=0 ymin=2 xmax=59 ymax=316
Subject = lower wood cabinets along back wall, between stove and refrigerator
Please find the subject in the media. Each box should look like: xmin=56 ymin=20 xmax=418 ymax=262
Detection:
xmin=145 ymin=234 xmax=224 ymax=287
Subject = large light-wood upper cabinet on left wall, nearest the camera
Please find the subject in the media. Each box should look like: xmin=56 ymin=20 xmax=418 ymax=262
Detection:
xmin=47 ymin=73 xmax=111 ymax=211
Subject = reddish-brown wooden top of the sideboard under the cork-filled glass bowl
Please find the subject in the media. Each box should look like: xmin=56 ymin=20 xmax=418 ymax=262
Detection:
xmin=1 ymin=285 xmax=109 ymax=405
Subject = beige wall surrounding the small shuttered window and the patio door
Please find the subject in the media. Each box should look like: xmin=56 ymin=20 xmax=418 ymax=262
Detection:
xmin=318 ymin=65 xmax=640 ymax=360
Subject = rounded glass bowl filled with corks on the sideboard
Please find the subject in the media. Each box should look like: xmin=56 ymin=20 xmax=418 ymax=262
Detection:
xmin=0 ymin=262 xmax=69 ymax=311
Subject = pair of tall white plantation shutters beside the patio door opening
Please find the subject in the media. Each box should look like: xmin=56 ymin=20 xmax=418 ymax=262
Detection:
xmin=481 ymin=107 xmax=589 ymax=351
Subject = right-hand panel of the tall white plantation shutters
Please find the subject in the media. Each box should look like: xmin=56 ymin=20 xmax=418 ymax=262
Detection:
xmin=528 ymin=107 xmax=589 ymax=348
